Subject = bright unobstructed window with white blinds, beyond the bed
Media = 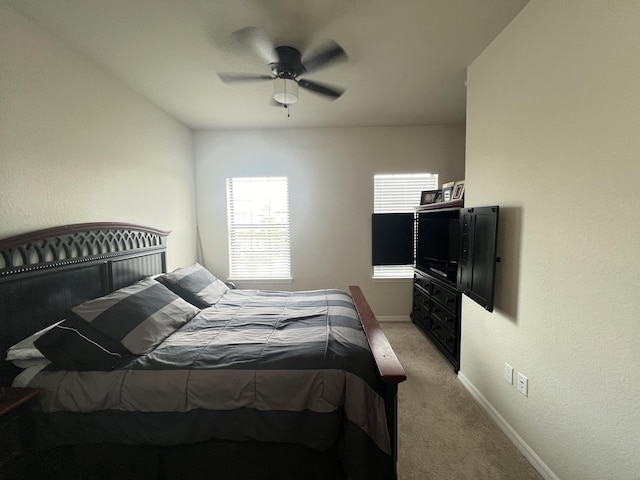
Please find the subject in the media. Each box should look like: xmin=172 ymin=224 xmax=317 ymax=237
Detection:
xmin=227 ymin=177 xmax=291 ymax=280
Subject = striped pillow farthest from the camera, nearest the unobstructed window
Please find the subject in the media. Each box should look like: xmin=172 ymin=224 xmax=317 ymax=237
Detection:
xmin=157 ymin=263 xmax=229 ymax=308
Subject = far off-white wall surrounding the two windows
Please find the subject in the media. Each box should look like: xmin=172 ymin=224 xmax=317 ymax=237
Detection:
xmin=195 ymin=126 xmax=464 ymax=316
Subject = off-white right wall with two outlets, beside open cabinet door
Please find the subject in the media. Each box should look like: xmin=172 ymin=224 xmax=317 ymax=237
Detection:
xmin=461 ymin=0 xmax=640 ymax=480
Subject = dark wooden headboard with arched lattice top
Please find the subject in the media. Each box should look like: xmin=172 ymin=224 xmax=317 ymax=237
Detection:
xmin=0 ymin=223 xmax=169 ymax=386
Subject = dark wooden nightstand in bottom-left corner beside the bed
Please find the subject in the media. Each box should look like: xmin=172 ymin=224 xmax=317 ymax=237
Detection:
xmin=0 ymin=387 xmax=40 ymax=472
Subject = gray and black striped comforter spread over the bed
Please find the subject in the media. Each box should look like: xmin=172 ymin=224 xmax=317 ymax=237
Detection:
xmin=29 ymin=290 xmax=391 ymax=478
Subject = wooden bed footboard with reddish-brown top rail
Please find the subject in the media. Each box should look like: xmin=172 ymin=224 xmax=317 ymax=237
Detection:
xmin=349 ymin=285 xmax=407 ymax=478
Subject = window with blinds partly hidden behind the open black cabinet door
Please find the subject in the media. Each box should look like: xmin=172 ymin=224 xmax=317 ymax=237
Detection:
xmin=373 ymin=173 xmax=438 ymax=278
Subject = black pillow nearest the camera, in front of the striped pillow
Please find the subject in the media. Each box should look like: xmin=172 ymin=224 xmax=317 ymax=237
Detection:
xmin=33 ymin=318 xmax=131 ymax=370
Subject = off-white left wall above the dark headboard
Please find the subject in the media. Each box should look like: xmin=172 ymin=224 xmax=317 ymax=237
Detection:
xmin=0 ymin=2 xmax=196 ymax=268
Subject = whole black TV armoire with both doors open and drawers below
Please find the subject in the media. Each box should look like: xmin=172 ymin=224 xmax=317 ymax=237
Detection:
xmin=372 ymin=199 xmax=500 ymax=372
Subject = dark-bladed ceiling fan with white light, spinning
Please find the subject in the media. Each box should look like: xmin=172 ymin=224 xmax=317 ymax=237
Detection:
xmin=218 ymin=27 xmax=347 ymax=108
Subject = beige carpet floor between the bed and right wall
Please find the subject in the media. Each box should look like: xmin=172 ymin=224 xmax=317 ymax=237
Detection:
xmin=383 ymin=322 xmax=542 ymax=480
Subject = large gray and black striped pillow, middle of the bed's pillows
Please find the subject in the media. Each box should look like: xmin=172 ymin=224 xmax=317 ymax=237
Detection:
xmin=68 ymin=278 xmax=200 ymax=355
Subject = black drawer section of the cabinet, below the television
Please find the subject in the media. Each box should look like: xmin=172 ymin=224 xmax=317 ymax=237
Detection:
xmin=411 ymin=269 xmax=461 ymax=373
